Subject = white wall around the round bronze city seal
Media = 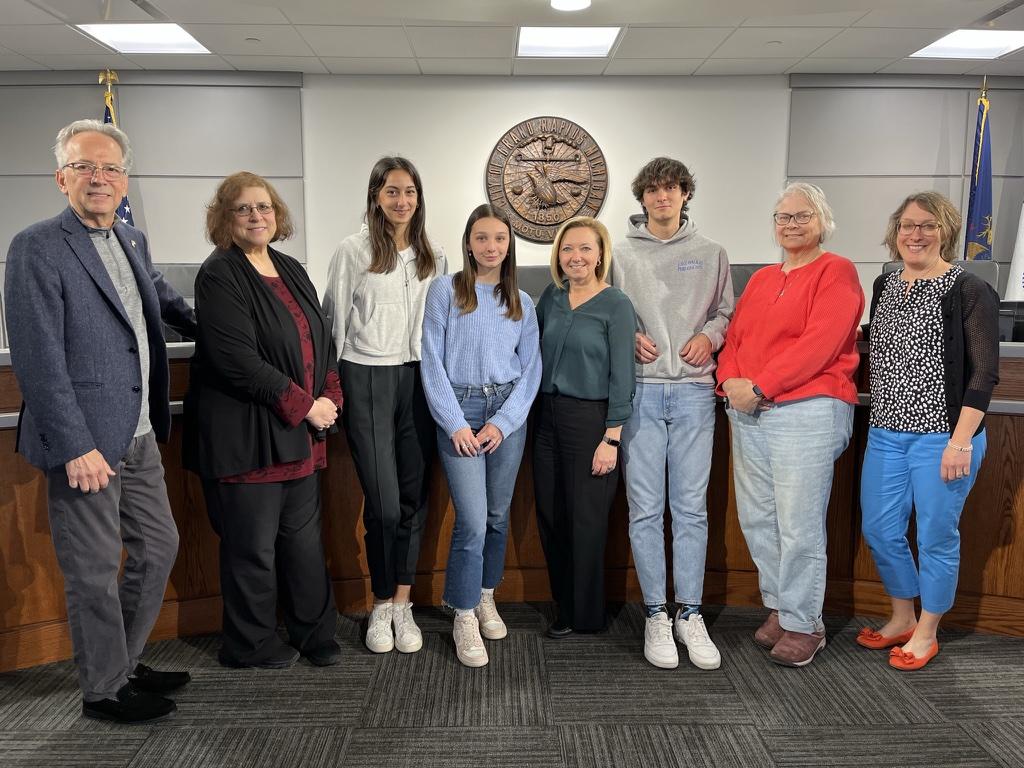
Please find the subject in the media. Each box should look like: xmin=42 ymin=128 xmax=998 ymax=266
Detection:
xmin=302 ymin=75 xmax=790 ymax=289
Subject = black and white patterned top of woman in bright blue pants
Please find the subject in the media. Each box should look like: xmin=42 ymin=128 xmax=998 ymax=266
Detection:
xmin=870 ymin=265 xmax=963 ymax=432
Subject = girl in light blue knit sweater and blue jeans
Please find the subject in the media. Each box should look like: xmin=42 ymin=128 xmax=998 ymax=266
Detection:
xmin=422 ymin=205 xmax=541 ymax=667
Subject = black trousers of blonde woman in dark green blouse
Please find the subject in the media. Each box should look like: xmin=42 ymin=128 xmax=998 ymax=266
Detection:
xmin=534 ymin=394 xmax=618 ymax=632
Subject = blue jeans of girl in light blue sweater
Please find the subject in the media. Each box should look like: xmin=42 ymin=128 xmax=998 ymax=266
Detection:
xmin=437 ymin=383 xmax=526 ymax=610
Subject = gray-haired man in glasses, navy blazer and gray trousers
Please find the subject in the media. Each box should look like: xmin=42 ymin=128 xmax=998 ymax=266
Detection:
xmin=5 ymin=120 xmax=196 ymax=723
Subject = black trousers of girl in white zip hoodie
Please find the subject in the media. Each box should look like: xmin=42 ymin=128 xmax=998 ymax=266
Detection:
xmin=339 ymin=360 xmax=437 ymax=600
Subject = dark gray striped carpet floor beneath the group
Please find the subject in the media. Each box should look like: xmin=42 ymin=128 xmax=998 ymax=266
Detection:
xmin=0 ymin=603 xmax=1024 ymax=768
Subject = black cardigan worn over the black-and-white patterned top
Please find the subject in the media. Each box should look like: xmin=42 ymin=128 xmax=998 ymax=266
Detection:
xmin=864 ymin=270 xmax=999 ymax=434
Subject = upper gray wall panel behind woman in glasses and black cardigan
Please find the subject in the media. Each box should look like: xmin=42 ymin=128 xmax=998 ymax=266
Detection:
xmin=119 ymin=86 xmax=302 ymax=177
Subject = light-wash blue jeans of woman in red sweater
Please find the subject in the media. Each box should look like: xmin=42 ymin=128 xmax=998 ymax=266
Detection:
xmin=727 ymin=397 xmax=853 ymax=633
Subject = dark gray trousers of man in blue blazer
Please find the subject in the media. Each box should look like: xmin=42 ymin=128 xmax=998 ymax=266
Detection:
xmin=46 ymin=431 xmax=178 ymax=701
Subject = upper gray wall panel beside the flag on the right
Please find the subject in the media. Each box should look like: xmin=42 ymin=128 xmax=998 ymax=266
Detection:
xmin=788 ymin=88 xmax=973 ymax=177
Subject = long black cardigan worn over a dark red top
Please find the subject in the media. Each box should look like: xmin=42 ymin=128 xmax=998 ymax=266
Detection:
xmin=182 ymin=247 xmax=337 ymax=478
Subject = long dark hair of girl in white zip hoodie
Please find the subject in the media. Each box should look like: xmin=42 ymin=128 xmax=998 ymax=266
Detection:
xmin=367 ymin=157 xmax=436 ymax=280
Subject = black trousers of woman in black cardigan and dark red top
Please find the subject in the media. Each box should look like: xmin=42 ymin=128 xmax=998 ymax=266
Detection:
xmin=203 ymin=472 xmax=338 ymax=664
